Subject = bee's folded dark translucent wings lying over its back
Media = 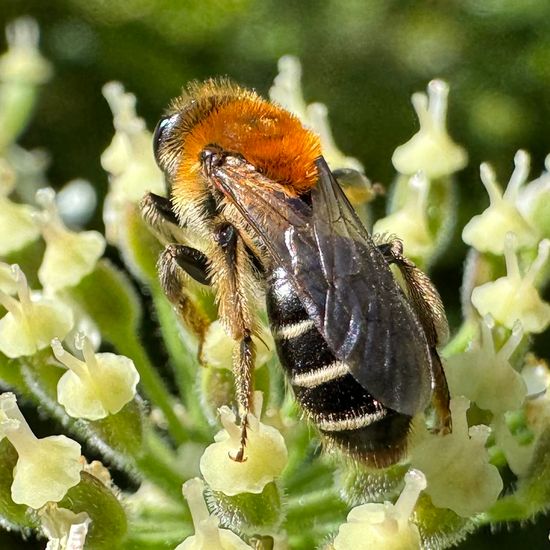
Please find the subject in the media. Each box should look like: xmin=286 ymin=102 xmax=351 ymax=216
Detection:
xmin=212 ymin=154 xmax=432 ymax=415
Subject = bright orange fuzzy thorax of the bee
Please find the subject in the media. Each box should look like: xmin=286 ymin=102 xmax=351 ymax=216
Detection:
xmin=176 ymin=83 xmax=321 ymax=195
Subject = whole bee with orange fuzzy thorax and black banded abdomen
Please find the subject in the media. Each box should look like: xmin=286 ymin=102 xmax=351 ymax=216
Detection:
xmin=142 ymin=80 xmax=450 ymax=467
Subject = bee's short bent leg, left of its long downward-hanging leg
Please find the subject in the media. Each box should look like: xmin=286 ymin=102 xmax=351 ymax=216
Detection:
xmin=157 ymin=244 xmax=210 ymax=350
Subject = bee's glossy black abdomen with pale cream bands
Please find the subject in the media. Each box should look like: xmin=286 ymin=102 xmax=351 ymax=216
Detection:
xmin=267 ymin=267 xmax=411 ymax=467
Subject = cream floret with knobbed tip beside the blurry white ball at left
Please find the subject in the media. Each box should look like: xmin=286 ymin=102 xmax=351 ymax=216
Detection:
xmin=36 ymin=188 xmax=105 ymax=292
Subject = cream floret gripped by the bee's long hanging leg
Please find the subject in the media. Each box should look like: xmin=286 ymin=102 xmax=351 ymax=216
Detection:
xmin=200 ymin=392 xmax=288 ymax=496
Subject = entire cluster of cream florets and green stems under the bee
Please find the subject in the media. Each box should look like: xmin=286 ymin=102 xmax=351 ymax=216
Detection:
xmin=0 ymin=20 xmax=550 ymax=550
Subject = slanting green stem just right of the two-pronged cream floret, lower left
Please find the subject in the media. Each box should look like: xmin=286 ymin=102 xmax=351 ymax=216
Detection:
xmin=113 ymin=331 xmax=189 ymax=445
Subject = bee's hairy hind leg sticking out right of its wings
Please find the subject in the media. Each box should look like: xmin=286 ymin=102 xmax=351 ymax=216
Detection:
xmin=378 ymin=239 xmax=451 ymax=432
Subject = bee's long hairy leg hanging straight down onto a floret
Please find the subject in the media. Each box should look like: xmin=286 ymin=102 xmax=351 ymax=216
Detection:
xmin=215 ymin=223 xmax=256 ymax=462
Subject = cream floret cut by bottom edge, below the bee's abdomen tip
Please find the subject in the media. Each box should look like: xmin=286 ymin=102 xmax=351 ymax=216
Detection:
xmin=333 ymin=470 xmax=426 ymax=550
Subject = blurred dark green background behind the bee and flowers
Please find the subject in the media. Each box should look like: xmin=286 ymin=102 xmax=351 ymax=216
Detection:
xmin=0 ymin=0 xmax=550 ymax=548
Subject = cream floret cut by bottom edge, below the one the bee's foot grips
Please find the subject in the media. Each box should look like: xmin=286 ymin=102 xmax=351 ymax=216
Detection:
xmin=175 ymin=478 xmax=252 ymax=550
